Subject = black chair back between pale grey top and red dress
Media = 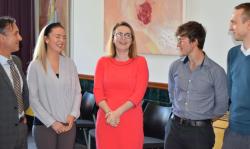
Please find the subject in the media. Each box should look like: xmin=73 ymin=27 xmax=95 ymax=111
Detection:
xmin=80 ymin=91 xmax=95 ymax=120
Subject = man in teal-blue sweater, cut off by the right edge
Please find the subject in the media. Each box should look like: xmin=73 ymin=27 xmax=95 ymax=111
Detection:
xmin=223 ymin=3 xmax=250 ymax=149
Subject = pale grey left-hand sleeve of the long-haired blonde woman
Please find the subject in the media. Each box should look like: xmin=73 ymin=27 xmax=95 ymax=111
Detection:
xmin=27 ymin=61 xmax=56 ymax=127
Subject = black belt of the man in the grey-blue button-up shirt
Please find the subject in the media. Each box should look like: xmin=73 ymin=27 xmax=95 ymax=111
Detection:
xmin=173 ymin=115 xmax=212 ymax=127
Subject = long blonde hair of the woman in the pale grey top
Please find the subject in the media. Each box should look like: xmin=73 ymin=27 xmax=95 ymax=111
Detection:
xmin=32 ymin=22 xmax=65 ymax=72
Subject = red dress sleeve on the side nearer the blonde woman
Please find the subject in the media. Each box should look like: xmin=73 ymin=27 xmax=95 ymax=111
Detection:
xmin=94 ymin=57 xmax=106 ymax=104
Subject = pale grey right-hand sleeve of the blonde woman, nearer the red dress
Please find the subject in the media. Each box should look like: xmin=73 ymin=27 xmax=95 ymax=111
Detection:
xmin=71 ymin=61 xmax=82 ymax=119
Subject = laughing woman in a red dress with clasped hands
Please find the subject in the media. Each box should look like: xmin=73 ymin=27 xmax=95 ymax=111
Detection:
xmin=94 ymin=22 xmax=148 ymax=149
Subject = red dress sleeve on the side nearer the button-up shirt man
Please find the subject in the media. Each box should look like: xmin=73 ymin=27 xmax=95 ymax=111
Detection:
xmin=129 ymin=57 xmax=149 ymax=106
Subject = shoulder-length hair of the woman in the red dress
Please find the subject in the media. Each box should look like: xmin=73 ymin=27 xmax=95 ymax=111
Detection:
xmin=107 ymin=21 xmax=137 ymax=58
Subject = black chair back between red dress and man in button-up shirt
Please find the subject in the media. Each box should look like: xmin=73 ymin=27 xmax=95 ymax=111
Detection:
xmin=143 ymin=102 xmax=171 ymax=140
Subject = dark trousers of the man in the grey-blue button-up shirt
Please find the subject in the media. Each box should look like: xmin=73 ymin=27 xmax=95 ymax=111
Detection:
xmin=165 ymin=119 xmax=215 ymax=149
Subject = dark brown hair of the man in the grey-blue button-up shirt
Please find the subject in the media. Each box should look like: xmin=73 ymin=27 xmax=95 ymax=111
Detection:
xmin=175 ymin=21 xmax=206 ymax=49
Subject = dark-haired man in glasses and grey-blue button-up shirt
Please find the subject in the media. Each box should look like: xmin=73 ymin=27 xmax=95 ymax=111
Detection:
xmin=165 ymin=21 xmax=228 ymax=149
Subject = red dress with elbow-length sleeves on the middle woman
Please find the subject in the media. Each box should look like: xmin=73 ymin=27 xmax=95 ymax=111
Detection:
xmin=94 ymin=56 xmax=148 ymax=149
